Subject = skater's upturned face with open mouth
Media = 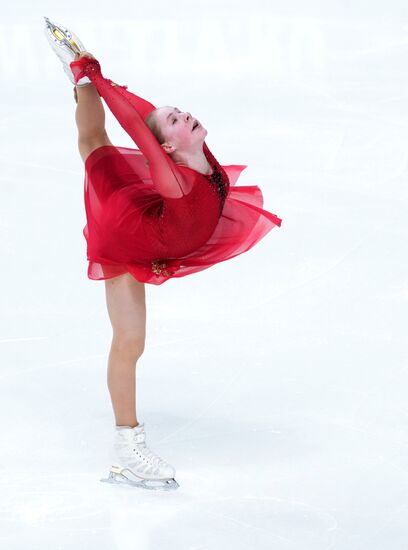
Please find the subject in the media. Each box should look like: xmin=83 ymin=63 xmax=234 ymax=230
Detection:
xmin=156 ymin=106 xmax=207 ymax=150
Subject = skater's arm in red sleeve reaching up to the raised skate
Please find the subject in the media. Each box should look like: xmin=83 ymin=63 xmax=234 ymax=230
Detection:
xmin=70 ymin=56 xmax=191 ymax=198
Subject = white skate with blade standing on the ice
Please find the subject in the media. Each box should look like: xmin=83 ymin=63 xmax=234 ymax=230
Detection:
xmin=101 ymin=423 xmax=179 ymax=491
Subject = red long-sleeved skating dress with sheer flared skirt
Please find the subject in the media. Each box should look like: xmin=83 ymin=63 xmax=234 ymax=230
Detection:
xmin=70 ymin=56 xmax=282 ymax=285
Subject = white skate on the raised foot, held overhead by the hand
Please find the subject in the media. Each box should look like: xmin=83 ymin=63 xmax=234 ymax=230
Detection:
xmin=44 ymin=16 xmax=91 ymax=86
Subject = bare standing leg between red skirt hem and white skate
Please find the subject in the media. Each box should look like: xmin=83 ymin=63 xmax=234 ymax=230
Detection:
xmin=105 ymin=273 xmax=146 ymax=427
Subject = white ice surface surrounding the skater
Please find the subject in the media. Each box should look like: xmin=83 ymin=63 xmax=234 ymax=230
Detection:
xmin=0 ymin=0 xmax=408 ymax=550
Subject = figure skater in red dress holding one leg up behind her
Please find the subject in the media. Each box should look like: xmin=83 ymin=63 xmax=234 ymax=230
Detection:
xmin=45 ymin=18 xmax=282 ymax=489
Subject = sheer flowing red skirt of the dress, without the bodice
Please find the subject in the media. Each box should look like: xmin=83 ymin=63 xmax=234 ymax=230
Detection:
xmin=83 ymin=146 xmax=282 ymax=285
